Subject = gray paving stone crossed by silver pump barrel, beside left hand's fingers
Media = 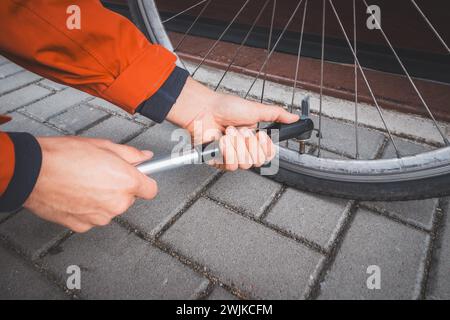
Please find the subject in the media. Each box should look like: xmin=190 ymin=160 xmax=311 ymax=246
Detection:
xmin=123 ymin=124 xmax=217 ymax=235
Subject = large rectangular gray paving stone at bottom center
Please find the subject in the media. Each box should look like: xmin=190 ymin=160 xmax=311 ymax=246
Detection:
xmin=161 ymin=198 xmax=321 ymax=299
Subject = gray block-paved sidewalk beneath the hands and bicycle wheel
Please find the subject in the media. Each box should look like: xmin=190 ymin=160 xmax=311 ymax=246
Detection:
xmin=0 ymin=57 xmax=450 ymax=299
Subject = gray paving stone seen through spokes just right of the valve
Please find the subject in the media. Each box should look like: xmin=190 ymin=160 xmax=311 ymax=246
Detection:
xmin=310 ymin=116 xmax=384 ymax=159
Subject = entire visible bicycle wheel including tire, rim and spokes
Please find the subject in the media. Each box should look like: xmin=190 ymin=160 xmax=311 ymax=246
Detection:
xmin=119 ymin=0 xmax=450 ymax=200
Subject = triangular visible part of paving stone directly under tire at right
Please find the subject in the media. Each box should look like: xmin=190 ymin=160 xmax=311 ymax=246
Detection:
xmin=363 ymin=199 xmax=438 ymax=230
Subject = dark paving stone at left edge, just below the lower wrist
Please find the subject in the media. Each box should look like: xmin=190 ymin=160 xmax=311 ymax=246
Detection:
xmin=0 ymin=210 xmax=68 ymax=259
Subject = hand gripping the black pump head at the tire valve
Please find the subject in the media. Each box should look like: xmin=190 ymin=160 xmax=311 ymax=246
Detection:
xmin=167 ymin=78 xmax=299 ymax=171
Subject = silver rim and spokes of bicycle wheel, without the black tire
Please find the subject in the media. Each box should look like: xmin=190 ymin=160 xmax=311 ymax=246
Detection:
xmin=135 ymin=0 xmax=450 ymax=183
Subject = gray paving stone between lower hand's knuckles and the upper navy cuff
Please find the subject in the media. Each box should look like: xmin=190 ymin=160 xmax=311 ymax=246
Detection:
xmin=81 ymin=116 xmax=143 ymax=143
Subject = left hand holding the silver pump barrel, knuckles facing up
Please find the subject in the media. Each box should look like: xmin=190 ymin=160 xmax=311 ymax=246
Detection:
xmin=25 ymin=137 xmax=158 ymax=232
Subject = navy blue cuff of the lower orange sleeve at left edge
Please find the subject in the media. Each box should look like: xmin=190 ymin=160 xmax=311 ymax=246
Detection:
xmin=0 ymin=132 xmax=42 ymax=212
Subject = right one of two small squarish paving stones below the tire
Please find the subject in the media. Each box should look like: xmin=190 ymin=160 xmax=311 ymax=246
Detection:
xmin=266 ymin=189 xmax=348 ymax=247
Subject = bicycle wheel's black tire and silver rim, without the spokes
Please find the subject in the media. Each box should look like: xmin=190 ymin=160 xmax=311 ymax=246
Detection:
xmin=128 ymin=0 xmax=450 ymax=201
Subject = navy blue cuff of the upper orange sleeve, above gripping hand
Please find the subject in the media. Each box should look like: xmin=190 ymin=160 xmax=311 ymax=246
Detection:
xmin=136 ymin=67 xmax=189 ymax=123
